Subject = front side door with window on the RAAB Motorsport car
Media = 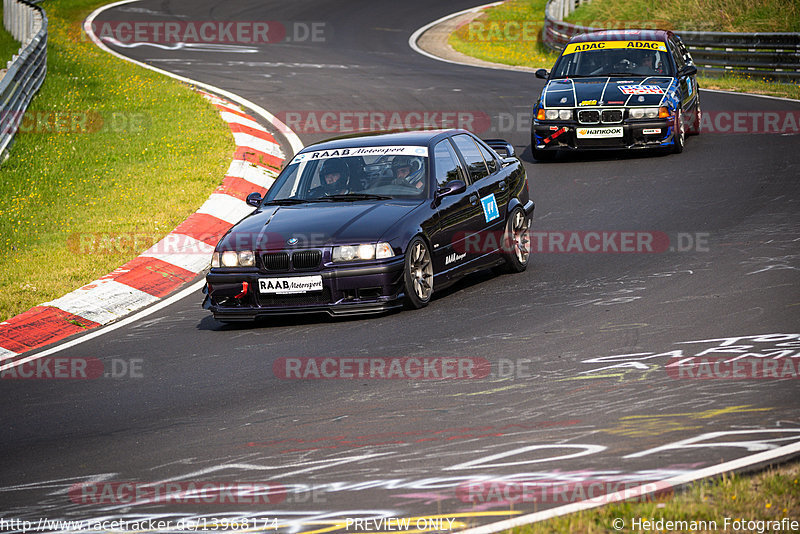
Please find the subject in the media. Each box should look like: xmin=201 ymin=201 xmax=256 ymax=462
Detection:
xmin=431 ymin=139 xmax=484 ymax=278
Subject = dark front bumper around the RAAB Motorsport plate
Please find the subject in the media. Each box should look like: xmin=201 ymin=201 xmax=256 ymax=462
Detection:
xmin=203 ymin=256 xmax=405 ymax=321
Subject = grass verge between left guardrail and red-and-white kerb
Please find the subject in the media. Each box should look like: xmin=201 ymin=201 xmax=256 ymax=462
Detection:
xmin=0 ymin=0 xmax=233 ymax=320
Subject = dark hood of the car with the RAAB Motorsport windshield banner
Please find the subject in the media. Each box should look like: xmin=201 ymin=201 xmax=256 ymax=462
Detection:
xmin=218 ymin=200 xmax=422 ymax=250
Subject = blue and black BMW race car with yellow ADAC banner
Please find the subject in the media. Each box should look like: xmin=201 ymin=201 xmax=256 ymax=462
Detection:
xmin=531 ymin=30 xmax=701 ymax=161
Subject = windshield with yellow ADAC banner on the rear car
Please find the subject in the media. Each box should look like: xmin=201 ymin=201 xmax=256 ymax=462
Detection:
xmin=550 ymin=41 xmax=673 ymax=79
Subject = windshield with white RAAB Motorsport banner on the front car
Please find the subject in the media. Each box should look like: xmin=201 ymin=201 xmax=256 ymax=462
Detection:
xmin=264 ymin=147 xmax=429 ymax=204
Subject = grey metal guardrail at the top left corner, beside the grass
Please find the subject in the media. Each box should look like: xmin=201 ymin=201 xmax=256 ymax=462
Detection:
xmin=0 ymin=0 xmax=47 ymax=162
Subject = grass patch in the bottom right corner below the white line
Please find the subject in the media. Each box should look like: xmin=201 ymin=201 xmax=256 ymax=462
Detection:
xmin=508 ymin=462 xmax=800 ymax=534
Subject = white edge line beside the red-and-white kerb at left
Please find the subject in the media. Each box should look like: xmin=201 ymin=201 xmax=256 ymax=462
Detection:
xmin=0 ymin=0 xmax=303 ymax=371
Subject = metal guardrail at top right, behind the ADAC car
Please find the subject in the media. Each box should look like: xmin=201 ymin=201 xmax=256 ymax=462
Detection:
xmin=542 ymin=0 xmax=800 ymax=82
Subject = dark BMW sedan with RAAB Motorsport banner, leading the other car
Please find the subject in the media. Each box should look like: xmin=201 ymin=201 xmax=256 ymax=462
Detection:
xmin=204 ymin=130 xmax=534 ymax=321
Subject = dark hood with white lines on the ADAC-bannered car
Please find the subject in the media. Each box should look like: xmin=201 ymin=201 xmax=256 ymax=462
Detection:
xmin=544 ymin=76 xmax=674 ymax=108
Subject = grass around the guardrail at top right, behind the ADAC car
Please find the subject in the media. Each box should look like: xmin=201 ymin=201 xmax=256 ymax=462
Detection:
xmin=448 ymin=0 xmax=800 ymax=99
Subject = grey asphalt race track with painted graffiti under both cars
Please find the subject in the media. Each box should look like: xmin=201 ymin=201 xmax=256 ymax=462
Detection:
xmin=0 ymin=0 xmax=800 ymax=532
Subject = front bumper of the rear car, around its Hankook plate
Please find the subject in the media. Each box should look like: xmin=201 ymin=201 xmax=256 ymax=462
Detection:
xmin=531 ymin=118 xmax=675 ymax=150
